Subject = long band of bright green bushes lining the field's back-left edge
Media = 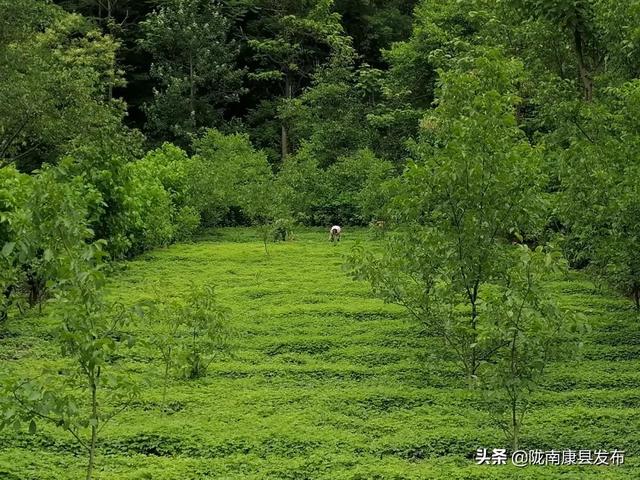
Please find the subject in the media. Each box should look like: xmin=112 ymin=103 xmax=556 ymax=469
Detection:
xmin=0 ymin=106 xmax=395 ymax=324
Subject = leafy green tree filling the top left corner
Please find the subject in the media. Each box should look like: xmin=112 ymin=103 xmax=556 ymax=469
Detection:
xmin=0 ymin=1 xmax=123 ymax=171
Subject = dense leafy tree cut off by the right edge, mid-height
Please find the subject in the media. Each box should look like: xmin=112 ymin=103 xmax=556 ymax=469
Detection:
xmin=558 ymin=81 xmax=640 ymax=310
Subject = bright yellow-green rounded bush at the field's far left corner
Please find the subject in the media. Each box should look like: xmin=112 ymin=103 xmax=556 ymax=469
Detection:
xmin=69 ymin=135 xmax=200 ymax=258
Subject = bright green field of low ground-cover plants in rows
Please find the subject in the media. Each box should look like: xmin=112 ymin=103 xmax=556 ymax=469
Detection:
xmin=0 ymin=230 xmax=640 ymax=480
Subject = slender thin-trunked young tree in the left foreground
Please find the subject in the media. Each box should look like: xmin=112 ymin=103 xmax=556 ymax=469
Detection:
xmin=0 ymin=239 xmax=138 ymax=480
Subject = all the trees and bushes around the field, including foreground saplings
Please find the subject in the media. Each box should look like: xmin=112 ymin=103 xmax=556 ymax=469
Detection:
xmin=0 ymin=0 xmax=640 ymax=478
